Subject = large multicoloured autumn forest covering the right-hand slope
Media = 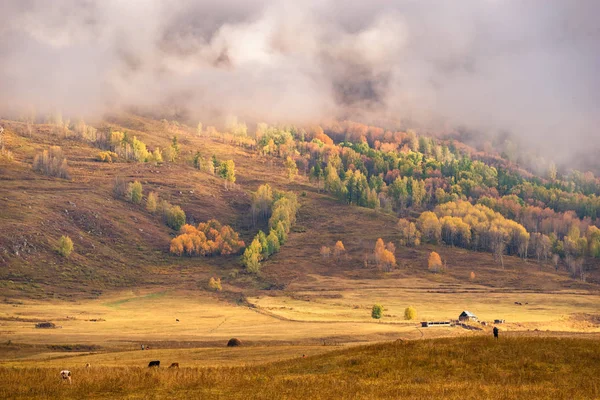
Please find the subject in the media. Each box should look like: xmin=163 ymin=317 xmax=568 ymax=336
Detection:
xmin=252 ymin=121 xmax=600 ymax=274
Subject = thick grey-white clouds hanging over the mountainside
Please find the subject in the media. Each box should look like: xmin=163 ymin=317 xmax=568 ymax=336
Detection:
xmin=0 ymin=0 xmax=600 ymax=161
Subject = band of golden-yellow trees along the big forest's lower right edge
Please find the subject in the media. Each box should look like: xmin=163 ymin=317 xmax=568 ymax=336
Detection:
xmin=396 ymin=201 xmax=600 ymax=279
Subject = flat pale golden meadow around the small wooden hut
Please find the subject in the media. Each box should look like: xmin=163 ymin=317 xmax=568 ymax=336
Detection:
xmin=0 ymin=282 xmax=600 ymax=365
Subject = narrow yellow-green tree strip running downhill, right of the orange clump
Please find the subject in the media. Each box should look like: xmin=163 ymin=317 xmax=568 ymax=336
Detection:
xmin=241 ymin=188 xmax=299 ymax=273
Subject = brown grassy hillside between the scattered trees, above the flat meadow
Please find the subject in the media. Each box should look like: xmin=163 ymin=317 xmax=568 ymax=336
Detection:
xmin=0 ymin=114 xmax=598 ymax=304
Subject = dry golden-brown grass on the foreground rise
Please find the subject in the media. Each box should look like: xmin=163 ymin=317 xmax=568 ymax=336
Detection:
xmin=0 ymin=337 xmax=600 ymax=400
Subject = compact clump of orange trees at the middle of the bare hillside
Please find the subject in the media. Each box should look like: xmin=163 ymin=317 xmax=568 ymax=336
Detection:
xmin=170 ymin=219 xmax=245 ymax=256
